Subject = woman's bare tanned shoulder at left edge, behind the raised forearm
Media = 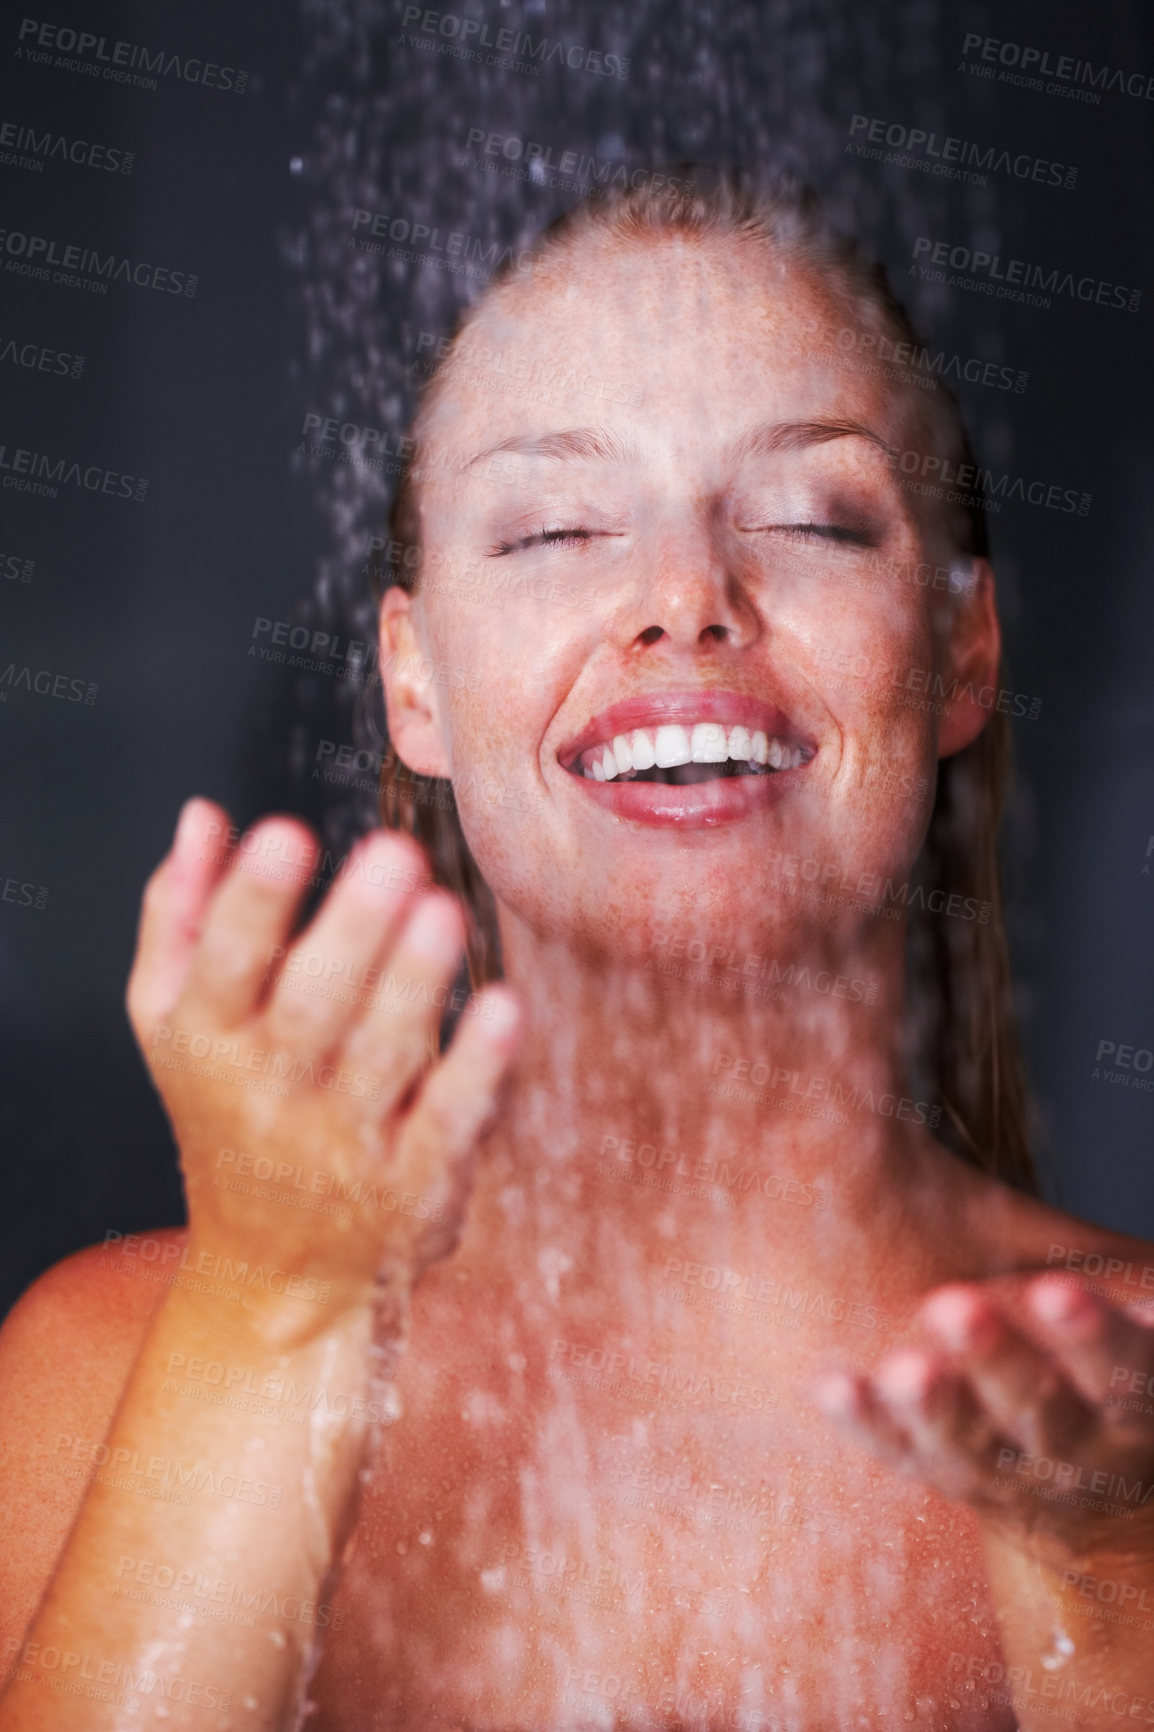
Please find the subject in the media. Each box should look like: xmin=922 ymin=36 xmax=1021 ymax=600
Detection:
xmin=0 ymin=1228 xmax=184 ymax=1652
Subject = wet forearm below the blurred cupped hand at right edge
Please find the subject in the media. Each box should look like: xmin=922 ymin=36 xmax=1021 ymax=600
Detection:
xmin=982 ymin=1514 xmax=1154 ymax=1732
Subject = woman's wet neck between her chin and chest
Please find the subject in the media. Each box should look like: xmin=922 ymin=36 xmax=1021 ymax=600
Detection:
xmin=471 ymin=909 xmax=943 ymax=1281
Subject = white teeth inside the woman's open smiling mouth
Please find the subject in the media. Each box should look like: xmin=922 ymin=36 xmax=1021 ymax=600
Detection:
xmin=568 ymin=721 xmax=814 ymax=786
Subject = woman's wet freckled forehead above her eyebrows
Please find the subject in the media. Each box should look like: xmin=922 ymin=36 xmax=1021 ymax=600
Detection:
xmin=421 ymin=232 xmax=910 ymax=468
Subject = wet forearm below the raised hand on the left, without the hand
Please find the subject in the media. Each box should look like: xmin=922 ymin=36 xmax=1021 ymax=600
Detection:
xmin=0 ymin=1290 xmax=385 ymax=1732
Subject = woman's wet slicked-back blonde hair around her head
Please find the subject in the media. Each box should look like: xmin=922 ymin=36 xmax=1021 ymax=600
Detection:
xmin=376 ymin=165 xmax=1036 ymax=1192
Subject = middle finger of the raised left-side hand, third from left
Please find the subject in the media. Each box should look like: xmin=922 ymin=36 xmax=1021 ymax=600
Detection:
xmin=263 ymin=830 xmax=428 ymax=1057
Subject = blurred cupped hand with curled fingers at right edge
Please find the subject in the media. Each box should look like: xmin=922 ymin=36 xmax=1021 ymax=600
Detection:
xmin=818 ymin=1275 xmax=1154 ymax=1562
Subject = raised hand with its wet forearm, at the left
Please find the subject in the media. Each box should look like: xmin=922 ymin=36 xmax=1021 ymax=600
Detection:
xmin=0 ymin=800 xmax=516 ymax=1732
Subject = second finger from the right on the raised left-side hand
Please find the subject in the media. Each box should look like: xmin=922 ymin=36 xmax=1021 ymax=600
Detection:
xmin=343 ymin=890 xmax=464 ymax=1119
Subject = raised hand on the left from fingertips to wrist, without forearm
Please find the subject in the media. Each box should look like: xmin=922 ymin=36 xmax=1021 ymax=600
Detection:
xmin=128 ymin=800 xmax=518 ymax=1335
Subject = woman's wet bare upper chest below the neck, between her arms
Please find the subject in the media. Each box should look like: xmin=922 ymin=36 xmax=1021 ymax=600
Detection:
xmin=303 ymin=1313 xmax=1014 ymax=1732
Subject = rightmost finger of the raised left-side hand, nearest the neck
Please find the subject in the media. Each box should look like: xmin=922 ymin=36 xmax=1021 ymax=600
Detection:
xmin=404 ymin=987 xmax=522 ymax=1254
